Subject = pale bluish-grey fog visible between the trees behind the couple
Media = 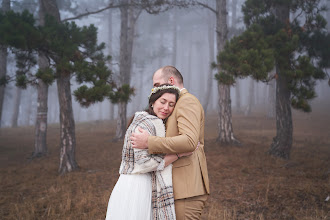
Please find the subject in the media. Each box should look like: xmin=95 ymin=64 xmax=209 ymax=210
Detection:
xmin=0 ymin=0 xmax=330 ymax=127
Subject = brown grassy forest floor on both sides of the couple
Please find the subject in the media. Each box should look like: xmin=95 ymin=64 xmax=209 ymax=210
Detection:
xmin=0 ymin=107 xmax=330 ymax=220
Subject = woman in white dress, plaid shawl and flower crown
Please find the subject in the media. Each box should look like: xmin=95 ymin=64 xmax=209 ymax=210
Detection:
xmin=106 ymin=84 xmax=191 ymax=220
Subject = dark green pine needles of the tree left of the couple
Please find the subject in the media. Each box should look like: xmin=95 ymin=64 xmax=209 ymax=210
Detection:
xmin=0 ymin=11 xmax=134 ymax=107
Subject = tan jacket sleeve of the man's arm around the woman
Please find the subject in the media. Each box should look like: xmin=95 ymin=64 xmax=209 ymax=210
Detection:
xmin=148 ymin=95 xmax=203 ymax=154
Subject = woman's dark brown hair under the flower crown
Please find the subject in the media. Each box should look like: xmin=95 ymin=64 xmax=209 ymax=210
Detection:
xmin=127 ymin=83 xmax=180 ymax=128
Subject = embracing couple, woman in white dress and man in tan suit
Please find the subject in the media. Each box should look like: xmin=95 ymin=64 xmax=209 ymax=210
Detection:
xmin=106 ymin=66 xmax=210 ymax=220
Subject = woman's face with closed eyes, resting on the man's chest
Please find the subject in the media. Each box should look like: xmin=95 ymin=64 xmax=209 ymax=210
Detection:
xmin=153 ymin=93 xmax=176 ymax=119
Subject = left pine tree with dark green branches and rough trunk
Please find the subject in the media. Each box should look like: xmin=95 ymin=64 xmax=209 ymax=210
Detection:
xmin=0 ymin=11 xmax=131 ymax=174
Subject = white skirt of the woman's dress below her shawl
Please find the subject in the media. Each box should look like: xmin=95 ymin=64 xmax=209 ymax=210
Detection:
xmin=106 ymin=173 xmax=152 ymax=220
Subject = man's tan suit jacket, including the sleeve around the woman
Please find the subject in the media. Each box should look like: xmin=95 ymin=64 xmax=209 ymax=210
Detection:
xmin=148 ymin=89 xmax=210 ymax=199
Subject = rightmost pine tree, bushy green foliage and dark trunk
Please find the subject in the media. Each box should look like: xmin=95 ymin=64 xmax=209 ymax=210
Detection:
xmin=219 ymin=0 xmax=330 ymax=159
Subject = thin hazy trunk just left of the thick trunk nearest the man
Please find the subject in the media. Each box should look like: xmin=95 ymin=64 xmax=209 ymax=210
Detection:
xmin=203 ymin=13 xmax=214 ymax=115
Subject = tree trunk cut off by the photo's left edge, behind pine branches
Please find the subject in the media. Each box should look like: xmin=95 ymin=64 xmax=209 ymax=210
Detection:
xmin=0 ymin=0 xmax=10 ymax=128
